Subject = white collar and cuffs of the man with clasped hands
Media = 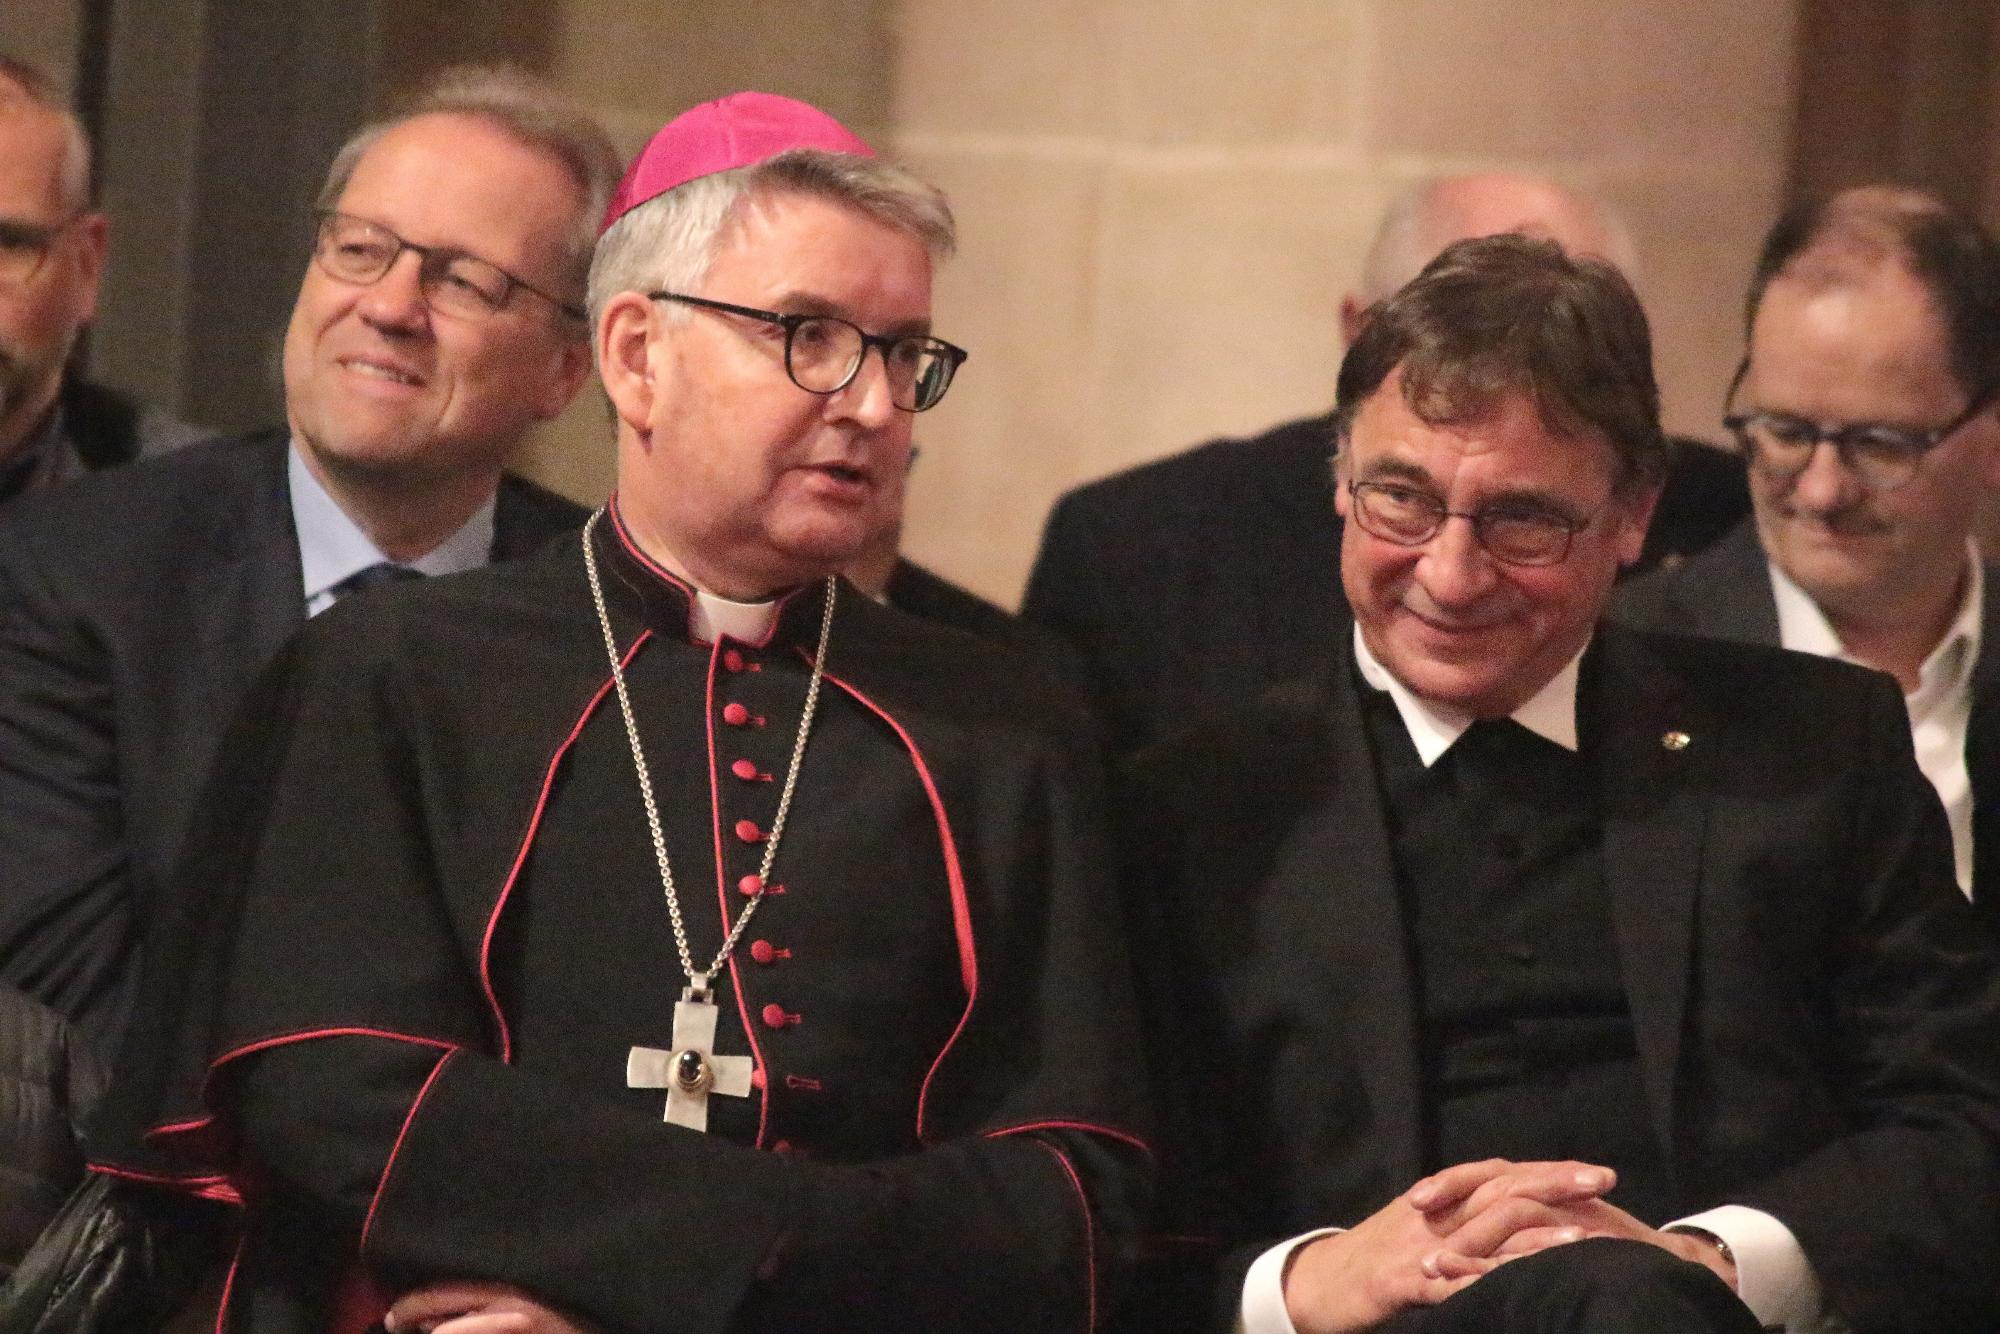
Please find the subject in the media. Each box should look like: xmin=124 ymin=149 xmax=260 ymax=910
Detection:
xmin=1240 ymin=626 xmax=1820 ymax=1334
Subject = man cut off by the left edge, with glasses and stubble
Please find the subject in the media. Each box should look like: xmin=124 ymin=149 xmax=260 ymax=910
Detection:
xmin=0 ymin=54 xmax=198 ymax=504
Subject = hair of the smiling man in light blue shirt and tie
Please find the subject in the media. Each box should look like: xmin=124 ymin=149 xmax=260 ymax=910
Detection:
xmin=318 ymin=66 xmax=620 ymax=294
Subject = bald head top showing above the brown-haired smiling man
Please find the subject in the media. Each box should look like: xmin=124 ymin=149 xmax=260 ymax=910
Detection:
xmin=1340 ymin=172 xmax=1638 ymax=342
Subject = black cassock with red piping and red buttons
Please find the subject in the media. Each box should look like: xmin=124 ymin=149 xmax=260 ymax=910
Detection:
xmin=98 ymin=514 xmax=1148 ymax=1330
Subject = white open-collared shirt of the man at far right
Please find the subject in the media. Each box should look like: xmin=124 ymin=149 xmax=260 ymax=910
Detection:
xmin=1764 ymin=548 xmax=1986 ymax=896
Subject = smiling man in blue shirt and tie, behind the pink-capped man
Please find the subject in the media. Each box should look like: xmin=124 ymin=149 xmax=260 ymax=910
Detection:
xmin=0 ymin=72 xmax=618 ymax=1052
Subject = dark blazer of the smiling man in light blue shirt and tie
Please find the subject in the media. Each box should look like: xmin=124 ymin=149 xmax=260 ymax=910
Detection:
xmin=0 ymin=430 xmax=584 ymax=1046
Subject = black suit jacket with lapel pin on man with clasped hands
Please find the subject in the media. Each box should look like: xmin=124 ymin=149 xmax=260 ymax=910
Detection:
xmin=1120 ymin=626 xmax=2000 ymax=1332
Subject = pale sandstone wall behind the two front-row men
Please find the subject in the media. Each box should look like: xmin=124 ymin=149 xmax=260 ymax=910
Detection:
xmin=892 ymin=0 xmax=1796 ymax=602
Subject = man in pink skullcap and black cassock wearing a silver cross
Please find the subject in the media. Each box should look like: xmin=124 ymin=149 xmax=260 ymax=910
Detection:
xmin=94 ymin=92 xmax=1148 ymax=1334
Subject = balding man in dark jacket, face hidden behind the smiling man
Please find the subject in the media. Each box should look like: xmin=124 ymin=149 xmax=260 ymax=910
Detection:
xmin=1022 ymin=172 xmax=1750 ymax=750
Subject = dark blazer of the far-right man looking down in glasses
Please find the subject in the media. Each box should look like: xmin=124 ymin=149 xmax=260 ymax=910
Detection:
xmin=1612 ymin=518 xmax=2000 ymax=924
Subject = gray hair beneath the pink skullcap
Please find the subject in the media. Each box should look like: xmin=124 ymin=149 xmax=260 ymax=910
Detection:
xmin=588 ymin=148 xmax=958 ymax=328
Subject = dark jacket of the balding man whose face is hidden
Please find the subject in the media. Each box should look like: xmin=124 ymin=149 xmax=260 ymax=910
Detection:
xmin=1022 ymin=416 xmax=1750 ymax=752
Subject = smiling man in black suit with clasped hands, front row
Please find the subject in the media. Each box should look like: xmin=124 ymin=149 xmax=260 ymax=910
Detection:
xmin=1120 ymin=236 xmax=2000 ymax=1334
